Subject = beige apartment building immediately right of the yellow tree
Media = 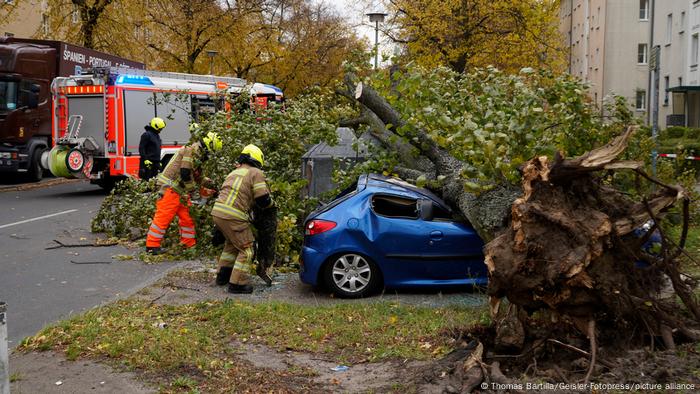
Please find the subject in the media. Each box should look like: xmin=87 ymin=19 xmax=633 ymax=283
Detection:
xmin=559 ymin=0 xmax=652 ymax=116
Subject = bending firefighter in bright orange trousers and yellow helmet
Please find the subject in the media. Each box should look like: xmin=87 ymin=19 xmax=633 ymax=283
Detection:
xmin=146 ymin=132 xmax=222 ymax=254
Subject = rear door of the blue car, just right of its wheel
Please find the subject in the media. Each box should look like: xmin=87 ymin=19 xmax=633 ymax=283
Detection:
xmin=368 ymin=193 xmax=427 ymax=285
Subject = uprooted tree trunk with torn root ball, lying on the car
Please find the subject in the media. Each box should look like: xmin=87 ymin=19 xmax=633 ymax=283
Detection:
xmin=346 ymin=77 xmax=700 ymax=388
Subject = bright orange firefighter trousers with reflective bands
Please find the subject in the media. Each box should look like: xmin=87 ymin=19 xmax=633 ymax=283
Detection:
xmin=146 ymin=187 xmax=197 ymax=248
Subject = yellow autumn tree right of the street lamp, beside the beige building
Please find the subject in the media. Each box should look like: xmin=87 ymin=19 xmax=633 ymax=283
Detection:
xmin=385 ymin=0 xmax=565 ymax=72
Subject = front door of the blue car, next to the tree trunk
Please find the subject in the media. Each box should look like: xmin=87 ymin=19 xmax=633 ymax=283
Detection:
xmin=419 ymin=199 xmax=486 ymax=280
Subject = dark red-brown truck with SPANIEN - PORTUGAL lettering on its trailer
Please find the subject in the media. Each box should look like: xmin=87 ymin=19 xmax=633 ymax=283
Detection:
xmin=0 ymin=37 xmax=145 ymax=181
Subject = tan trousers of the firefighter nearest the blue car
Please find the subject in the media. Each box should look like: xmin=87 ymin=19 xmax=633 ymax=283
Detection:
xmin=213 ymin=216 xmax=255 ymax=285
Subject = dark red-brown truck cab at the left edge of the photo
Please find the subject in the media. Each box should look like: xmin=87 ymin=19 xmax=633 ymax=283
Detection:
xmin=0 ymin=43 xmax=51 ymax=180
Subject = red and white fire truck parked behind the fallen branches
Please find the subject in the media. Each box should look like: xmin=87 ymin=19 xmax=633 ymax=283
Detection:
xmin=42 ymin=67 xmax=284 ymax=189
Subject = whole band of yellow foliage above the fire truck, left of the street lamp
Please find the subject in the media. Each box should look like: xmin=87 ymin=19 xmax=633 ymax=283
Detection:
xmin=32 ymin=0 xmax=361 ymax=96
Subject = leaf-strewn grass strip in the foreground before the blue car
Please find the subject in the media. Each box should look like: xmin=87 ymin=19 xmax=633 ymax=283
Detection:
xmin=19 ymin=299 xmax=489 ymax=391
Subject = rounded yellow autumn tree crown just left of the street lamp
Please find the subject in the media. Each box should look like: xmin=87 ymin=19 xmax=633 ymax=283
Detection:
xmin=217 ymin=0 xmax=362 ymax=95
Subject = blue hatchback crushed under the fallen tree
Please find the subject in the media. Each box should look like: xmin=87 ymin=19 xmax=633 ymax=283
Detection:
xmin=299 ymin=174 xmax=487 ymax=298
